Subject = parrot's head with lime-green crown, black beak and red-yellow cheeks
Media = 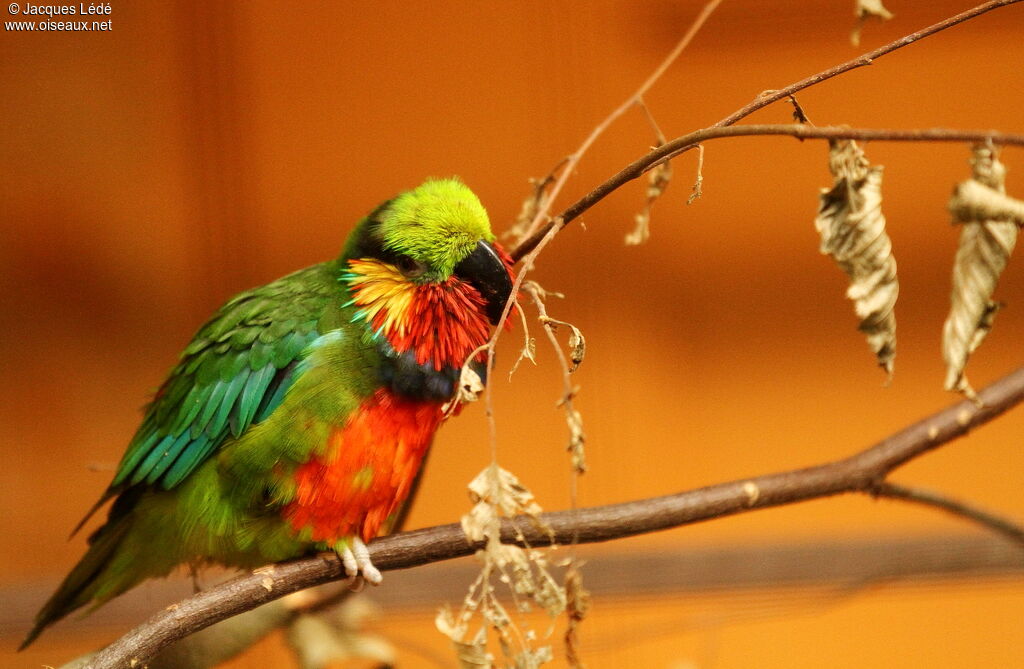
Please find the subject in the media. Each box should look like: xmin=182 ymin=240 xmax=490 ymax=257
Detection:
xmin=341 ymin=178 xmax=514 ymax=370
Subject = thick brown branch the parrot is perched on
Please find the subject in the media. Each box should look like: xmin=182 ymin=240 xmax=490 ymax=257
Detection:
xmin=88 ymin=368 xmax=1024 ymax=669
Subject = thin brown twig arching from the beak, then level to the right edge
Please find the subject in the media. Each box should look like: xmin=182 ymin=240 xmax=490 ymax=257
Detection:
xmin=510 ymin=124 xmax=1024 ymax=260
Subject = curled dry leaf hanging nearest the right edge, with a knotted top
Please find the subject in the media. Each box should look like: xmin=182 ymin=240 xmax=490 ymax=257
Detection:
xmin=942 ymin=144 xmax=1024 ymax=399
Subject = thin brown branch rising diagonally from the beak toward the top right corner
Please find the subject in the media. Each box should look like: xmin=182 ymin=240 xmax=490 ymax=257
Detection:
xmin=511 ymin=0 xmax=1020 ymax=261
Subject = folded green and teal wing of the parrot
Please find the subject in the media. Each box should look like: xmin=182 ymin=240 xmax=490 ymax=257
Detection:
xmin=109 ymin=263 xmax=340 ymax=494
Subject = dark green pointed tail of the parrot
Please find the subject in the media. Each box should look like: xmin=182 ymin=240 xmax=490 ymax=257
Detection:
xmin=17 ymin=499 xmax=139 ymax=651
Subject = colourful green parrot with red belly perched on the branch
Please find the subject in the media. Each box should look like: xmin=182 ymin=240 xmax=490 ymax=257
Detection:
xmin=20 ymin=177 xmax=515 ymax=649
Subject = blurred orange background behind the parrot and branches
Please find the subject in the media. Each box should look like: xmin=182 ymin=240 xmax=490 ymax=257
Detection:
xmin=0 ymin=0 xmax=1024 ymax=668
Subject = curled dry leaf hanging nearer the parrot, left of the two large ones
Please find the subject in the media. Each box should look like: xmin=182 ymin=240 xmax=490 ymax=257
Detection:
xmin=814 ymin=140 xmax=899 ymax=378
